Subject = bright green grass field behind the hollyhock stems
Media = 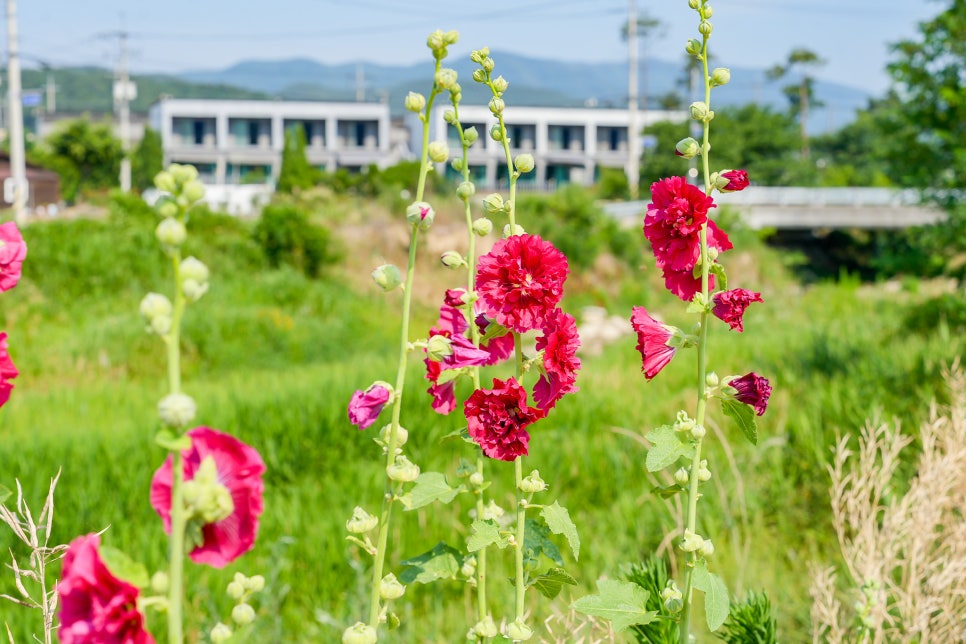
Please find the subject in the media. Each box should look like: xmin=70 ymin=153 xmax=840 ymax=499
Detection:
xmin=0 ymin=199 xmax=963 ymax=642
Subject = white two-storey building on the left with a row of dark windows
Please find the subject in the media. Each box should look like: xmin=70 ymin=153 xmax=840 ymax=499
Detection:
xmin=149 ymin=98 xmax=397 ymax=184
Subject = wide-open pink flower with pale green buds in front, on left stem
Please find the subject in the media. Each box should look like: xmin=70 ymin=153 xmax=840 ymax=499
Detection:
xmin=151 ymin=427 xmax=265 ymax=568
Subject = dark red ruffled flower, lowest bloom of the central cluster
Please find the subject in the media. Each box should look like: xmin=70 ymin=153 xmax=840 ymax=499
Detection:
xmin=463 ymin=378 xmax=543 ymax=461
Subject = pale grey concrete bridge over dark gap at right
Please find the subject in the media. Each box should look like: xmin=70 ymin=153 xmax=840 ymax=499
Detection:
xmin=604 ymin=186 xmax=945 ymax=230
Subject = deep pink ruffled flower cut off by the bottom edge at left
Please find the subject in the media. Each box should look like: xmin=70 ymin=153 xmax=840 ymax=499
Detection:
xmin=57 ymin=534 xmax=154 ymax=644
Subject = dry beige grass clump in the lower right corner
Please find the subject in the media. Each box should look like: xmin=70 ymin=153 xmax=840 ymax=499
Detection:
xmin=810 ymin=364 xmax=966 ymax=642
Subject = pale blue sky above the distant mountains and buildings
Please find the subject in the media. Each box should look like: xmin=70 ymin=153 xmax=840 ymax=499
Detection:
xmin=9 ymin=0 xmax=945 ymax=94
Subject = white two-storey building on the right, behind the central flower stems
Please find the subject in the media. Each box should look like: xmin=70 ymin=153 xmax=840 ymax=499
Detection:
xmin=406 ymin=105 xmax=688 ymax=190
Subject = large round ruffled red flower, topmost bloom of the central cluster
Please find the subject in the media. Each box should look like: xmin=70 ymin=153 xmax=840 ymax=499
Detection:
xmin=476 ymin=235 xmax=569 ymax=333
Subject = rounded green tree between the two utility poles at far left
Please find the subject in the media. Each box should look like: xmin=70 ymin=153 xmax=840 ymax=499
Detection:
xmin=41 ymin=119 xmax=123 ymax=202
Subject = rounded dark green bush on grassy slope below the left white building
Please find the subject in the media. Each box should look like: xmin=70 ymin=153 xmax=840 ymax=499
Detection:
xmin=252 ymin=205 xmax=339 ymax=277
